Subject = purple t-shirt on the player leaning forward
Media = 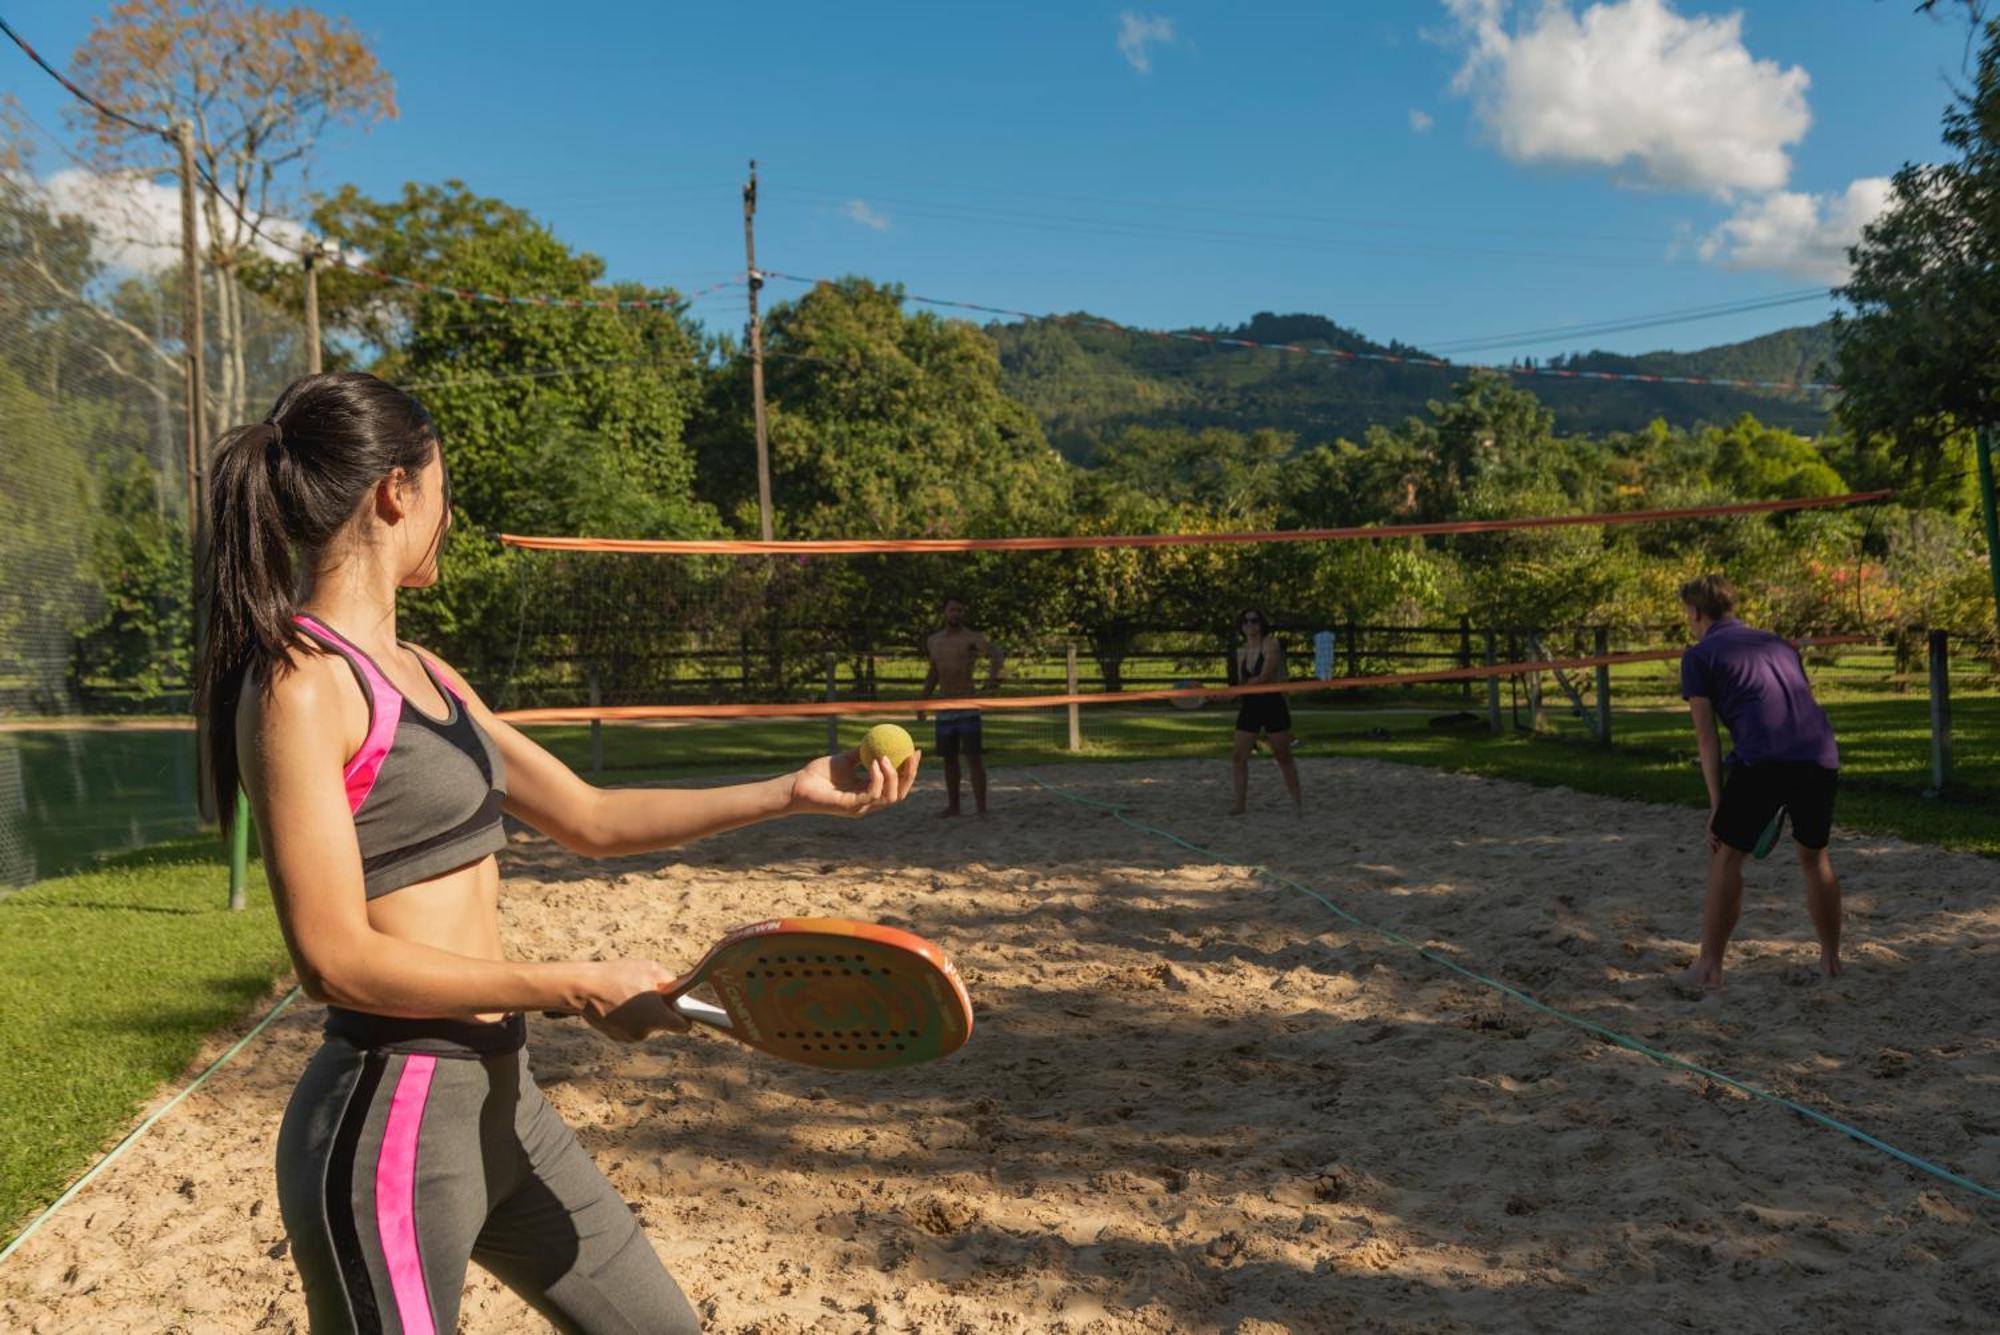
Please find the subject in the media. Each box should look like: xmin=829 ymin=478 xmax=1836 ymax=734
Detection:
xmin=1680 ymin=618 xmax=1840 ymax=769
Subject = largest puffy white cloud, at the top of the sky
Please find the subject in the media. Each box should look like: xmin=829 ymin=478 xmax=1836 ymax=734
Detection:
xmin=1444 ymin=0 xmax=1812 ymax=198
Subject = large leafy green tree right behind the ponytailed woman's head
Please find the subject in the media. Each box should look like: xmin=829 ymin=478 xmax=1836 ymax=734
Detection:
xmin=268 ymin=182 xmax=720 ymax=683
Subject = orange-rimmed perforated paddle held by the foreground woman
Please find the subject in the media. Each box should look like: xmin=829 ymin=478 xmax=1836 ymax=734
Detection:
xmin=550 ymin=917 xmax=972 ymax=1071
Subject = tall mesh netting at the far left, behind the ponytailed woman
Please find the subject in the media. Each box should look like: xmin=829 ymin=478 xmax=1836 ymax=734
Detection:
xmin=0 ymin=169 xmax=306 ymax=885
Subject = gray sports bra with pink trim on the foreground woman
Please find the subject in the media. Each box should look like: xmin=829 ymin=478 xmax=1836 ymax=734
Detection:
xmin=292 ymin=616 xmax=506 ymax=899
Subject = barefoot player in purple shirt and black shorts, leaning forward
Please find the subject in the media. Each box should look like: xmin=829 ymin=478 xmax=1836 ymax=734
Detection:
xmin=1680 ymin=576 xmax=1840 ymax=987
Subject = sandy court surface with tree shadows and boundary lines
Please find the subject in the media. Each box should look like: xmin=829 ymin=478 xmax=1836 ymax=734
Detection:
xmin=0 ymin=759 xmax=2000 ymax=1335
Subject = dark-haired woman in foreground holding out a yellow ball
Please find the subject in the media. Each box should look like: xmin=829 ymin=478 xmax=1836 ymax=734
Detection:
xmin=198 ymin=374 xmax=916 ymax=1335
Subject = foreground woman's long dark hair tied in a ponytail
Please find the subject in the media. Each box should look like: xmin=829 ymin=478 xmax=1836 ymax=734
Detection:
xmin=194 ymin=372 xmax=438 ymax=825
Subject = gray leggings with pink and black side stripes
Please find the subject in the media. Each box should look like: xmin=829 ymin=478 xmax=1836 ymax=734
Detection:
xmin=278 ymin=1021 xmax=700 ymax=1335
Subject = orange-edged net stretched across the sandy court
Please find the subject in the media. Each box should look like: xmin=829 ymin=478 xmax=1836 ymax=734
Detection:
xmin=486 ymin=492 xmax=1888 ymax=769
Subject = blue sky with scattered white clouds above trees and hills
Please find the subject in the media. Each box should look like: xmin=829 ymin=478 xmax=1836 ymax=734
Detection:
xmin=0 ymin=0 xmax=1964 ymax=360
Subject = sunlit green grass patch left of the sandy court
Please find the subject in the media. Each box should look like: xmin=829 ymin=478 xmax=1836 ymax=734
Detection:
xmin=0 ymin=837 xmax=286 ymax=1245
